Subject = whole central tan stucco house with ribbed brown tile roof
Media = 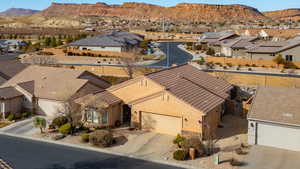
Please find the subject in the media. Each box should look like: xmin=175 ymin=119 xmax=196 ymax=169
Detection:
xmin=78 ymin=64 xmax=233 ymax=138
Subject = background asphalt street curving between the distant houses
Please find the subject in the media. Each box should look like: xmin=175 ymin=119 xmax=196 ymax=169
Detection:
xmin=150 ymin=42 xmax=193 ymax=67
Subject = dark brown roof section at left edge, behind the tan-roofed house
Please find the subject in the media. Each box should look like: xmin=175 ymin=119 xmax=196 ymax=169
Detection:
xmin=0 ymin=60 xmax=27 ymax=85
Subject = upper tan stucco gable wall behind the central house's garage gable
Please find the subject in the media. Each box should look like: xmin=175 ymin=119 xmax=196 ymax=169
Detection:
xmin=108 ymin=77 xmax=163 ymax=104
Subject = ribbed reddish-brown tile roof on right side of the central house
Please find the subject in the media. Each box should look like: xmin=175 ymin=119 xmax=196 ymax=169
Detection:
xmin=146 ymin=64 xmax=233 ymax=113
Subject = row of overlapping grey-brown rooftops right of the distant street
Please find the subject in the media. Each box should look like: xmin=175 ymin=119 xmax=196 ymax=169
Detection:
xmin=200 ymin=30 xmax=300 ymax=54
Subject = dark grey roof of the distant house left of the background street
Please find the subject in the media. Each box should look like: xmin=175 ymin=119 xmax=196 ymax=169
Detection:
xmin=69 ymin=32 xmax=144 ymax=47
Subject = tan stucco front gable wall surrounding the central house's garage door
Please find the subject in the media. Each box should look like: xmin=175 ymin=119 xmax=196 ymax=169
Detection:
xmin=132 ymin=92 xmax=203 ymax=133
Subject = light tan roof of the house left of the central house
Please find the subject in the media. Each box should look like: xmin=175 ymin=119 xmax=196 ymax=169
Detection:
xmin=1 ymin=66 xmax=106 ymax=101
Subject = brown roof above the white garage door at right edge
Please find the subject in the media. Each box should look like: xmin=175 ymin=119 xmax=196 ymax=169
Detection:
xmin=248 ymin=87 xmax=300 ymax=126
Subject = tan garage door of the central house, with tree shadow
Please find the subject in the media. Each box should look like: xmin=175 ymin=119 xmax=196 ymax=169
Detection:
xmin=142 ymin=112 xmax=182 ymax=136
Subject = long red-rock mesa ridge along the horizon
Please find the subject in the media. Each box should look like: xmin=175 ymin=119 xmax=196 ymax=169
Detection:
xmin=40 ymin=2 xmax=267 ymax=22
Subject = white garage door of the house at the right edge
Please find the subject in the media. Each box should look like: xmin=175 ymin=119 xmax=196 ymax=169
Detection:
xmin=257 ymin=123 xmax=300 ymax=151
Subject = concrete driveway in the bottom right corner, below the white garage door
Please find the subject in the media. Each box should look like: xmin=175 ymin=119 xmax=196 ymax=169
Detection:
xmin=241 ymin=146 xmax=300 ymax=169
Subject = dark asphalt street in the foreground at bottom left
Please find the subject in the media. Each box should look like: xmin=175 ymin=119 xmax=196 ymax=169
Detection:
xmin=0 ymin=135 xmax=185 ymax=169
